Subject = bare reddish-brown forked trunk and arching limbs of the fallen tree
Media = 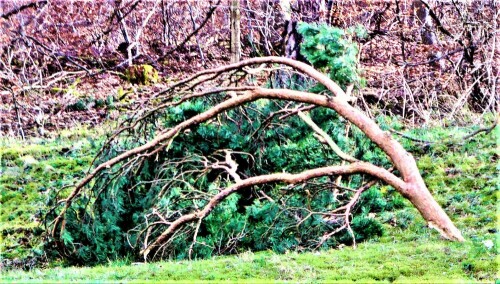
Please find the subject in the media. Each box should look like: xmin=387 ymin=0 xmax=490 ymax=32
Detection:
xmin=47 ymin=57 xmax=464 ymax=259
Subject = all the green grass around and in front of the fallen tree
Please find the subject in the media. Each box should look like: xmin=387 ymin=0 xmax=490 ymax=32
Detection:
xmin=0 ymin=121 xmax=500 ymax=283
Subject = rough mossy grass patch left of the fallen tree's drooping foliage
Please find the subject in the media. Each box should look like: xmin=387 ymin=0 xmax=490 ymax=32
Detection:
xmin=0 ymin=129 xmax=103 ymax=262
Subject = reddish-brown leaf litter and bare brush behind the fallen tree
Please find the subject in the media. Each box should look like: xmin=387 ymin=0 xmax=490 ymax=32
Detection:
xmin=0 ymin=0 xmax=499 ymax=136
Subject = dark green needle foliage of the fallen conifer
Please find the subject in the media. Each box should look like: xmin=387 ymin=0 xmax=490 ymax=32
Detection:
xmin=43 ymin=25 xmax=391 ymax=265
